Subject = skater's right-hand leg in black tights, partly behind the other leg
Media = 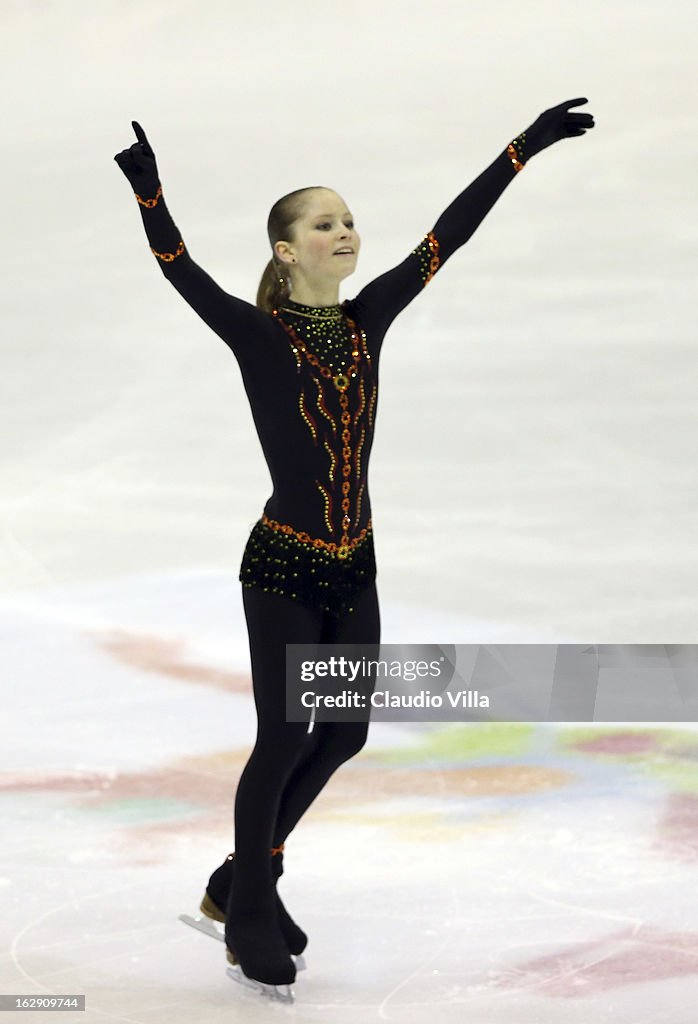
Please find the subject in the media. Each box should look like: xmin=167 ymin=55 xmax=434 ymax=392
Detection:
xmin=273 ymin=583 xmax=381 ymax=846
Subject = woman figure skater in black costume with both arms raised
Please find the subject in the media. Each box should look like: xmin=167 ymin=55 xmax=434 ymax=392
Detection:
xmin=115 ymin=98 xmax=594 ymax=998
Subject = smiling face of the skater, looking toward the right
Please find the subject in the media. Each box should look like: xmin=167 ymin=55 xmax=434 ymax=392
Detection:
xmin=274 ymin=188 xmax=361 ymax=283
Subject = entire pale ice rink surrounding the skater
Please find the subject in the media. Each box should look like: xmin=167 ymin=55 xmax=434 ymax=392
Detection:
xmin=0 ymin=0 xmax=698 ymax=1024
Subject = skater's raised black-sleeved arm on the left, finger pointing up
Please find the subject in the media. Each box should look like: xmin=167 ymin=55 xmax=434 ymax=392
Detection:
xmin=114 ymin=121 xmax=268 ymax=356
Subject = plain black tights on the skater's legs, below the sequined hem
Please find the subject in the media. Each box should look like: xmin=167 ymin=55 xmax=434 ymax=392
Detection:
xmin=235 ymin=583 xmax=381 ymax=888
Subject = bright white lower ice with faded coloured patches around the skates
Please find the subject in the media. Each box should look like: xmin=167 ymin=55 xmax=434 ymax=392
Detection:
xmin=0 ymin=572 xmax=698 ymax=1024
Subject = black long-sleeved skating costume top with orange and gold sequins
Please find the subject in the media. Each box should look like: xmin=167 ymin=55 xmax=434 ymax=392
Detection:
xmin=132 ymin=144 xmax=516 ymax=615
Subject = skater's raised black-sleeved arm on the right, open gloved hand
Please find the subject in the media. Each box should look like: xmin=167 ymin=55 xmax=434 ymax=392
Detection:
xmin=352 ymin=98 xmax=594 ymax=332
